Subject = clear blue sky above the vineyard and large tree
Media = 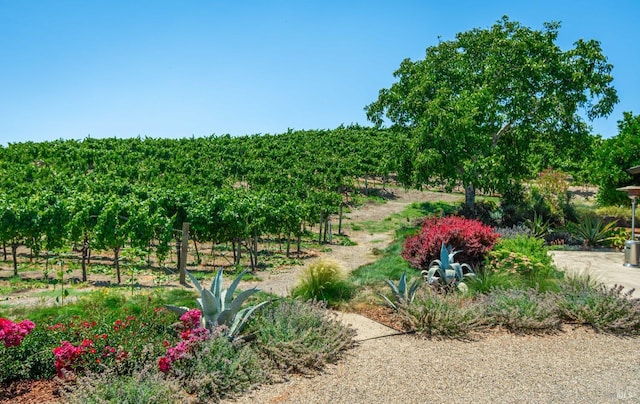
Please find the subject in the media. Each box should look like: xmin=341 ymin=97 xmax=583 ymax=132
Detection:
xmin=0 ymin=0 xmax=640 ymax=145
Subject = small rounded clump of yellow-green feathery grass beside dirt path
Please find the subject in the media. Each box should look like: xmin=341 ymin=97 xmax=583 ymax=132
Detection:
xmin=291 ymin=260 xmax=353 ymax=306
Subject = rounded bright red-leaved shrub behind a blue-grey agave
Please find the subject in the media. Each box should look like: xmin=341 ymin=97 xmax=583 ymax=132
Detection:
xmin=402 ymin=216 xmax=498 ymax=270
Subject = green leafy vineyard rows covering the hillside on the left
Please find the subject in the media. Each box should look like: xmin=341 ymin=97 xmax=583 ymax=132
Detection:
xmin=0 ymin=126 xmax=398 ymax=283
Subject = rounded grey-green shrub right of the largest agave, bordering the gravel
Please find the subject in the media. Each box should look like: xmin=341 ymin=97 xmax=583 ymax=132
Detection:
xmin=248 ymin=300 xmax=355 ymax=373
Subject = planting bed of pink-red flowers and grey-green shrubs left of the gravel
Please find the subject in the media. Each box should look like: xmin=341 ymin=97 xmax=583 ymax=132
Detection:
xmin=0 ymin=293 xmax=355 ymax=402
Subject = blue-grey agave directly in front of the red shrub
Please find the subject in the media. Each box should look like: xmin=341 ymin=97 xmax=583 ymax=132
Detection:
xmin=422 ymin=243 xmax=475 ymax=293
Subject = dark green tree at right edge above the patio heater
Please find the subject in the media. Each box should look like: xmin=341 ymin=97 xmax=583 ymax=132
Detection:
xmin=591 ymin=112 xmax=640 ymax=206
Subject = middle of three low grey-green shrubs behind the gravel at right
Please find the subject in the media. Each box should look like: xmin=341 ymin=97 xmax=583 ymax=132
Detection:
xmin=482 ymin=289 xmax=561 ymax=333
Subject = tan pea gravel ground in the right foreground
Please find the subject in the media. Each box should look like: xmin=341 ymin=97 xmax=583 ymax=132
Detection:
xmin=227 ymin=316 xmax=640 ymax=403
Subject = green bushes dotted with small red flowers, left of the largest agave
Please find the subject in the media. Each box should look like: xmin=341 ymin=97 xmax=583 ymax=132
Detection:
xmin=0 ymin=290 xmax=175 ymax=381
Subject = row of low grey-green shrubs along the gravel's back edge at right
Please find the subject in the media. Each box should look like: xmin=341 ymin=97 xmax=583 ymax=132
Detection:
xmin=397 ymin=275 xmax=640 ymax=339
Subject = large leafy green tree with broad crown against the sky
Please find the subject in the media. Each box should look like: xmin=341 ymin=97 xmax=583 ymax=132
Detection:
xmin=365 ymin=17 xmax=618 ymax=207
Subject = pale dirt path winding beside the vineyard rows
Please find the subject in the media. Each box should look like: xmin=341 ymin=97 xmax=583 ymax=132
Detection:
xmin=242 ymin=189 xmax=463 ymax=296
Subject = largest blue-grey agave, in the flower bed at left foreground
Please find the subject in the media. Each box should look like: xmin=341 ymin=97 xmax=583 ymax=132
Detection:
xmin=166 ymin=269 xmax=267 ymax=339
